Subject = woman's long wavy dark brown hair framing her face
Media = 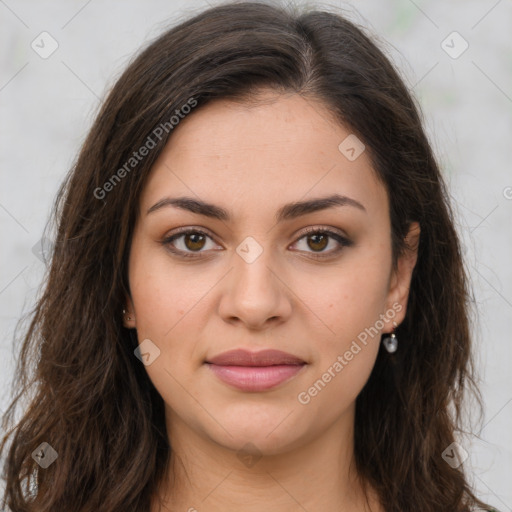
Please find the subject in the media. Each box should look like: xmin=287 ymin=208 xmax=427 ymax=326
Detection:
xmin=1 ymin=2 xmax=496 ymax=512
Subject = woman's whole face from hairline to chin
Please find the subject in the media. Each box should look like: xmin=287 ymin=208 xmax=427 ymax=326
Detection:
xmin=126 ymin=91 xmax=418 ymax=454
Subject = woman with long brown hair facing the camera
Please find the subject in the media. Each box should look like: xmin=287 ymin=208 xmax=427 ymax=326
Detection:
xmin=2 ymin=3 xmax=500 ymax=512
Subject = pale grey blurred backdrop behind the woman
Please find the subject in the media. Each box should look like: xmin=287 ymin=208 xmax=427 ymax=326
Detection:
xmin=0 ymin=0 xmax=512 ymax=511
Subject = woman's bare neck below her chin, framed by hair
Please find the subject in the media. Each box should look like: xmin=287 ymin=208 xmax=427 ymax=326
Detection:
xmin=151 ymin=404 xmax=382 ymax=512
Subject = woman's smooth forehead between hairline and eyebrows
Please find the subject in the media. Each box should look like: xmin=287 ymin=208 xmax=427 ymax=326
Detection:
xmin=141 ymin=92 xmax=387 ymax=219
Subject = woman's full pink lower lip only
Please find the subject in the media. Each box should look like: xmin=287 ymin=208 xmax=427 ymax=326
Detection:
xmin=208 ymin=363 xmax=306 ymax=391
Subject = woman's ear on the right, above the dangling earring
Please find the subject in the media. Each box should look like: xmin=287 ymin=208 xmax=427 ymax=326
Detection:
xmin=386 ymin=222 xmax=421 ymax=332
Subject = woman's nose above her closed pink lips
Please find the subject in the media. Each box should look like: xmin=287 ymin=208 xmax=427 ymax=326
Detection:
xmin=219 ymin=245 xmax=293 ymax=330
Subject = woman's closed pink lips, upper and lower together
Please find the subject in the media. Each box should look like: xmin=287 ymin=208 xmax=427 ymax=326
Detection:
xmin=206 ymin=350 xmax=306 ymax=391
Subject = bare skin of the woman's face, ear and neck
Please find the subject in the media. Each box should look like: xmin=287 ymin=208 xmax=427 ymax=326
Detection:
xmin=125 ymin=90 xmax=420 ymax=512
